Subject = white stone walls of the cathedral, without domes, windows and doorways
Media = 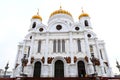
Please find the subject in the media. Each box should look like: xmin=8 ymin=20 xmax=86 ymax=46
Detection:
xmin=14 ymin=9 xmax=111 ymax=77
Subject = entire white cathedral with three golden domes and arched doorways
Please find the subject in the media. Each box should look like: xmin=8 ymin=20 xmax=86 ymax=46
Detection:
xmin=13 ymin=6 xmax=112 ymax=77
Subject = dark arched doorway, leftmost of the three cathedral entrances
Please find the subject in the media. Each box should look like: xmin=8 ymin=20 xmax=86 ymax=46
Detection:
xmin=33 ymin=61 xmax=41 ymax=77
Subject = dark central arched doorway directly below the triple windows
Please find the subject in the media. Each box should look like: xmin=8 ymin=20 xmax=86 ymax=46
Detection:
xmin=54 ymin=60 xmax=64 ymax=77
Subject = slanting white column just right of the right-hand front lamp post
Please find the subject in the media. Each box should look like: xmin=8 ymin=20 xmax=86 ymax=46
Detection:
xmin=95 ymin=38 xmax=104 ymax=75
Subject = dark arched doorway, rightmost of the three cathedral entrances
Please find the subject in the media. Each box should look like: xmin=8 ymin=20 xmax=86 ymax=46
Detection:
xmin=77 ymin=61 xmax=86 ymax=77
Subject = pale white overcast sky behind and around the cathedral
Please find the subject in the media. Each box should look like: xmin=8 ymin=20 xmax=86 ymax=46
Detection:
xmin=0 ymin=0 xmax=120 ymax=73
